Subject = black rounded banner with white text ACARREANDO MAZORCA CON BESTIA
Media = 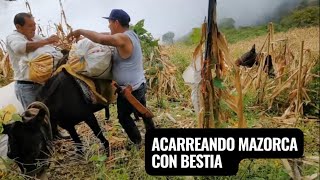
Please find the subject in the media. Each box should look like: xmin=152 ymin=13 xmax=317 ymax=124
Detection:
xmin=145 ymin=129 xmax=303 ymax=175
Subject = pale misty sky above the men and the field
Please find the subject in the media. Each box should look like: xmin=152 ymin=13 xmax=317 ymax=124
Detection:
xmin=0 ymin=0 xmax=300 ymax=39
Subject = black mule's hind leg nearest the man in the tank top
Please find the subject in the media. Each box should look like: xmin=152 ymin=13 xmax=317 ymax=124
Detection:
xmin=85 ymin=114 xmax=110 ymax=156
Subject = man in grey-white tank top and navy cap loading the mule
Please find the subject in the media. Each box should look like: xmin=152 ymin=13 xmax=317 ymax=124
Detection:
xmin=67 ymin=9 xmax=155 ymax=144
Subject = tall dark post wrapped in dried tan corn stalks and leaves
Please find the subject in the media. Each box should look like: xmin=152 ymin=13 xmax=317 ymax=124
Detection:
xmin=194 ymin=1 xmax=246 ymax=128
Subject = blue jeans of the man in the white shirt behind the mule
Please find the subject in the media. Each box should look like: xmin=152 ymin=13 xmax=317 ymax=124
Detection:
xmin=14 ymin=82 xmax=42 ymax=110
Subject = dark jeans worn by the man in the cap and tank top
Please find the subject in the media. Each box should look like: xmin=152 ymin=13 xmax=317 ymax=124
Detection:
xmin=117 ymin=83 xmax=155 ymax=144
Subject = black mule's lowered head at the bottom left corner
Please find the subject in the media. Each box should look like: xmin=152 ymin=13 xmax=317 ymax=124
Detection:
xmin=3 ymin=109 xmax=50 ymax=175
